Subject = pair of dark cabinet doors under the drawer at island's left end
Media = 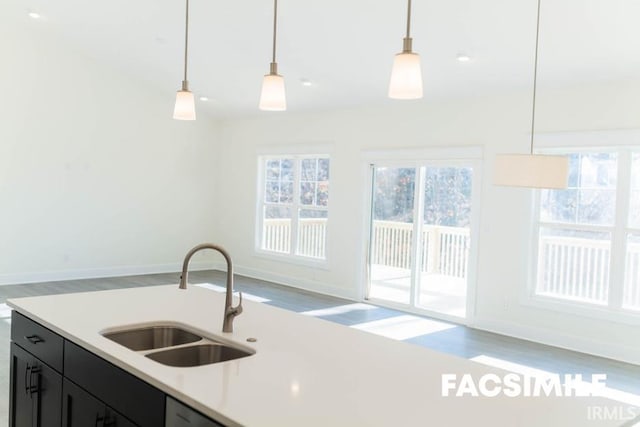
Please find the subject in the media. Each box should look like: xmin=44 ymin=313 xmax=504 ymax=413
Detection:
xmin=9 ymin=343 xmax=62 ymax=427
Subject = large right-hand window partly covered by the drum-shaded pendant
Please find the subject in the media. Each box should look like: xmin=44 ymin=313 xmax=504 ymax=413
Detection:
xmin=535 ymin=149 xmax=640 ymax=311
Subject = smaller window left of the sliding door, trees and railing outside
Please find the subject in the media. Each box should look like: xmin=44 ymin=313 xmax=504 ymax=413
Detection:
xmin=258 ymin=155 xmax=329 ymax=260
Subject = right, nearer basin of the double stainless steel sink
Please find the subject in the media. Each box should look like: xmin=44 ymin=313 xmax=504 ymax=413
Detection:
xmin=146 ymin=343 xmax=253 ymax=367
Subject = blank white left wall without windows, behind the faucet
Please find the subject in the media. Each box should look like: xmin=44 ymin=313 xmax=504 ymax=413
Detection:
xmin=0 ymin=11 xmax=217 ymax=284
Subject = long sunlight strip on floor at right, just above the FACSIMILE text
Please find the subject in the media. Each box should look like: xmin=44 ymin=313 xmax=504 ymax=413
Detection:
xmin=470 ymin=355 xmax=640 ymax=406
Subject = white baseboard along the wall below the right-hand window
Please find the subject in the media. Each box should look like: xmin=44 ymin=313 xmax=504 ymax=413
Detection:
xmin=470 ymin=318 xmax=640 ymax=365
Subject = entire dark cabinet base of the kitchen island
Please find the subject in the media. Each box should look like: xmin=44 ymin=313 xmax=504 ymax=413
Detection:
xmin=9 ymin=311 xmax=221 ymax=427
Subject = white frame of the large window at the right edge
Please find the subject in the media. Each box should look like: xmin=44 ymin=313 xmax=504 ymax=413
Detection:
xmin=523 ymin=137 xmax=640 ymax=325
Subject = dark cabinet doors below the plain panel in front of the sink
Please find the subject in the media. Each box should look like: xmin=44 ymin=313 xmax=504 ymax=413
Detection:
xmin=62 ymin=378 xmax=135 ymax=427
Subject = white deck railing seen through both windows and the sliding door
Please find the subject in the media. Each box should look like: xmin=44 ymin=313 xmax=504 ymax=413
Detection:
xmin=262 ymin=218 xmax=640 ymax=309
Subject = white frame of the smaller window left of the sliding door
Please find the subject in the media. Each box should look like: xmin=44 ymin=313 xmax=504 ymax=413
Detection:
xmin=254 ymin=153 xmax=332 ymax=269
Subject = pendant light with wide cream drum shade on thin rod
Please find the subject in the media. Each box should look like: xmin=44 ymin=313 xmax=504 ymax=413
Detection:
xmin=493 ymin=0 xmax=569 ymax=189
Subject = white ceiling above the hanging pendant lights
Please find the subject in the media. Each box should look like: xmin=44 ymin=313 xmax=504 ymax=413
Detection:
xmin=8 ymin=0 xmax=640 ymax=118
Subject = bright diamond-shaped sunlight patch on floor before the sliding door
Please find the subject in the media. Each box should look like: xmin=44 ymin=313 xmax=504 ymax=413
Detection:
xmin=351 ymin=314 xmax=457 ymax=340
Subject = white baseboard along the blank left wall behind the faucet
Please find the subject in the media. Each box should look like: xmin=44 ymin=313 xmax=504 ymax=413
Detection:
xmin=0 ymin=261 xmax=211 ymax=286
